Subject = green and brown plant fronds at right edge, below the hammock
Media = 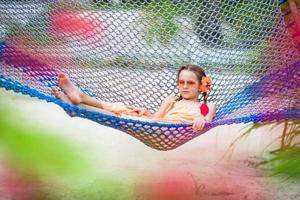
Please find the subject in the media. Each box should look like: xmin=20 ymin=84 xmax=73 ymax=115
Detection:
xmin=228 ymin=119 xmax=300 ymax=180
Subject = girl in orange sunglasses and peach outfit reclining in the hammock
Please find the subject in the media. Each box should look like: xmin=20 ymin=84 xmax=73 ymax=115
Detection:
xmin=52 ymin=64 xmax=215 ymax=131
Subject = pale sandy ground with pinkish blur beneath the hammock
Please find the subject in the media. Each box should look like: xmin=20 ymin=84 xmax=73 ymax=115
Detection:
xmin=0 ymin=89 xmax=300 ymax=200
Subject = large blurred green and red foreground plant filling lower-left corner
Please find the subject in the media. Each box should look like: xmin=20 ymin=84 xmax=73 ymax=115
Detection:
xmin=0 ymin=95 xmax=132 ymax=200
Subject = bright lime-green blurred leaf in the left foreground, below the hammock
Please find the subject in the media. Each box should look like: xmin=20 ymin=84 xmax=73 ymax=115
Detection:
xmin=0 ymin=99 xmax=87 ymax=176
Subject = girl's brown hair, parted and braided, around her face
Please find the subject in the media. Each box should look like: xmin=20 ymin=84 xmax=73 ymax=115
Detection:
xmin=176 ymin=64 xmax=207 ymax=103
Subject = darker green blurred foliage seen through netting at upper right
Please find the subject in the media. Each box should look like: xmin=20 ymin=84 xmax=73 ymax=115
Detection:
xmin=219 ymin=0 xmax=278 ymax=47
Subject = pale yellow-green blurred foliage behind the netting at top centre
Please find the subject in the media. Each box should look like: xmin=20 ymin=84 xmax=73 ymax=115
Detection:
xmin=94 ymin=0 xmax=185 ymax=44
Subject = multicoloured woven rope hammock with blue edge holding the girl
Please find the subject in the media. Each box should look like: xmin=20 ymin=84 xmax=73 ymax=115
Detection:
xmin=0 ymin=0 xmax=300 ymax=150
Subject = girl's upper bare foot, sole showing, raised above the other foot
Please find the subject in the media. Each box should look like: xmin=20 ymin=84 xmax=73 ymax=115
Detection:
xmin=58 ymin=73 xmax=84 ymax=105
